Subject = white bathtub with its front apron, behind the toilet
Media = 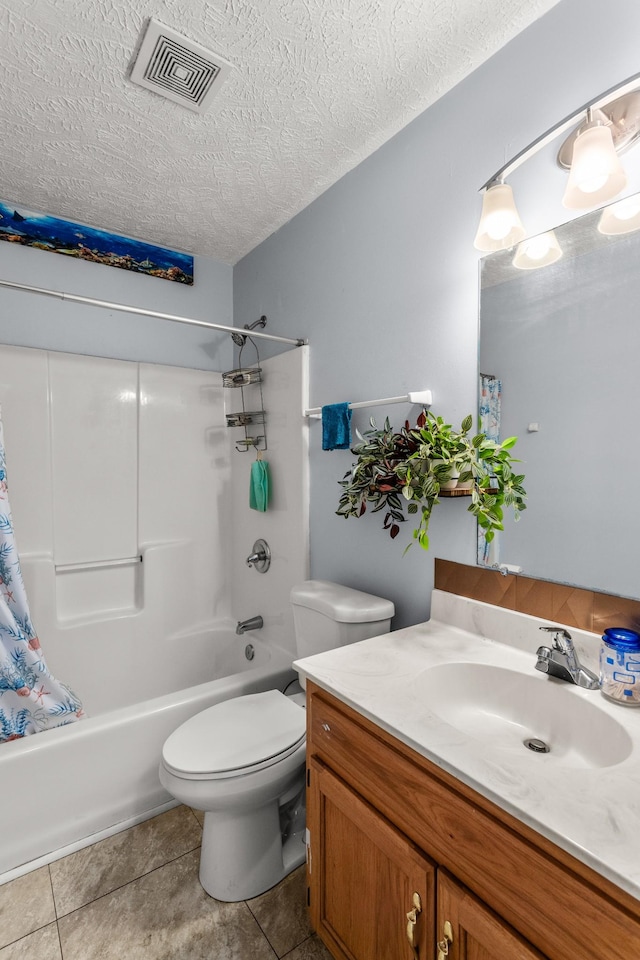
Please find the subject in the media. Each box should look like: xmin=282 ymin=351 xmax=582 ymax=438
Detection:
xmin=0 ymin=631 xmax=296 ymax=883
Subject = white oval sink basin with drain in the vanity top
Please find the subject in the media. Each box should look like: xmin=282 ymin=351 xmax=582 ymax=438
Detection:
xmin=414 ymin=663 xmax=633 ymax=768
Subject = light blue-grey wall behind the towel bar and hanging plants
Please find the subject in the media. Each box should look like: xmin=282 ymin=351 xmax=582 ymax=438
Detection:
xmin=234 ymin=0 xmax=640 ymax=625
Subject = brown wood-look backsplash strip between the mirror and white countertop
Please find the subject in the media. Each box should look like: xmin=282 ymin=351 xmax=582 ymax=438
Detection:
xmin=435 ymin=559 xmax=640 ymax=634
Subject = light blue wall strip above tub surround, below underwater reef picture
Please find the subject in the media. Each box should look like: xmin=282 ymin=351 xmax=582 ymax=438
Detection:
xmin=0 ymin=236 xmax=233 ymax=370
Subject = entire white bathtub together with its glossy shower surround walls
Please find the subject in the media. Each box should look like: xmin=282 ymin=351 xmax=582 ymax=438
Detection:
xmin=0 ymin=345 xmax=308 ymax=883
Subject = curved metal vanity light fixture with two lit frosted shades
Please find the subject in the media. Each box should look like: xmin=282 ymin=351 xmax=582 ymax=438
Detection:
xmin=474 ymin=74 xmax=640 ymax=251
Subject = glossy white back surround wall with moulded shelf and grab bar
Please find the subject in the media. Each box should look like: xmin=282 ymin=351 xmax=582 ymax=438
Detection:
xmin=0 ymin=346 xmax=232 ymax=716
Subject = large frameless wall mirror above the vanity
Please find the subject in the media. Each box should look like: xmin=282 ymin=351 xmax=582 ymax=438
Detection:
xmin=480 ymin=197 xmax=640 ymax=599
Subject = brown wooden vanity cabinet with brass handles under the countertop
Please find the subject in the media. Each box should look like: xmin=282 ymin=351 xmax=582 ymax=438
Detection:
xmin=307 ymin=682 xmax=640 ymax=960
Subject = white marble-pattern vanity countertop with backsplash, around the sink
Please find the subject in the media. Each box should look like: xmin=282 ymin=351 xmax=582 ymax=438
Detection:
xmin=294 ymin=590 xmax=640 ymax=900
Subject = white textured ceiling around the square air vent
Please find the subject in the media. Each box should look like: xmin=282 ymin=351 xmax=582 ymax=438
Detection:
xmin=0 ymin=0 xmax=558 ymax=263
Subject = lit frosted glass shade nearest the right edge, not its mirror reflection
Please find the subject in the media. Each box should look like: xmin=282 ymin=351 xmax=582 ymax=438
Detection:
xmin=562 ymin=124 xmax=627 ymax=210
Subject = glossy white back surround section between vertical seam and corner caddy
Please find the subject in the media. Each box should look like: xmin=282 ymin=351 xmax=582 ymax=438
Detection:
xmin=138 ymin=364 xmax=234 ymax=630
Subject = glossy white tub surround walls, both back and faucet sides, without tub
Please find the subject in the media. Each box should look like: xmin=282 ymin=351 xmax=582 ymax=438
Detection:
xmin=0 ymin=346 xmax=309 ymax=692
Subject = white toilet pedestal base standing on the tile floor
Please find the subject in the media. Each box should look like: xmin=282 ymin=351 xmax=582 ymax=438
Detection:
xmin=200 ymin=800 xmax=306 ymax=903
